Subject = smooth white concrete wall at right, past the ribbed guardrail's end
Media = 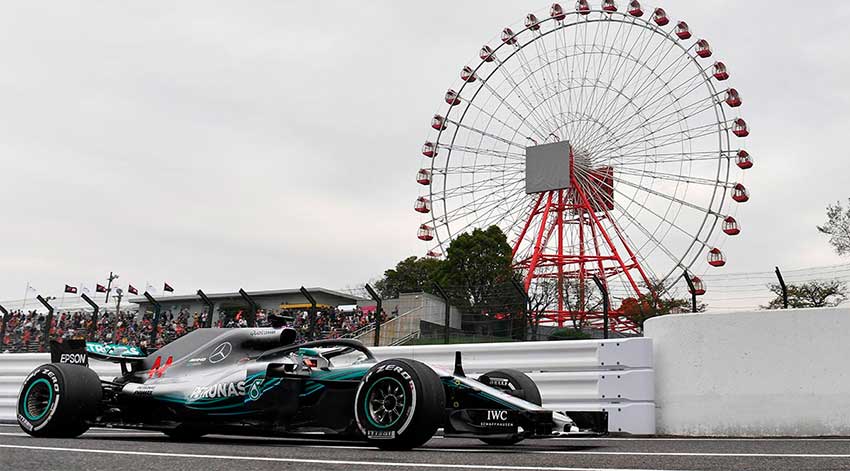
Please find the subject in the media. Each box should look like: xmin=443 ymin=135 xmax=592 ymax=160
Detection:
xmin=645 ymin=308 xmax=850 ymax=436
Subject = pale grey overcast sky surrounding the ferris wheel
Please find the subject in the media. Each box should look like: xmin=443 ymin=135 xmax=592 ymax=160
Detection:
xmin=0 ymin=0 xmax=850 ymax=306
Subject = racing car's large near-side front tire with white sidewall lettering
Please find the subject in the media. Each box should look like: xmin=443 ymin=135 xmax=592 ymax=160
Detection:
xmin=354 ymin=359 xmax=446 ymax=450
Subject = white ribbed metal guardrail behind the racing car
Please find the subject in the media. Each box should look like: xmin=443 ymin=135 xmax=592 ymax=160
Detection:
xmin=0 ymin=338 xmax=655 ymax=435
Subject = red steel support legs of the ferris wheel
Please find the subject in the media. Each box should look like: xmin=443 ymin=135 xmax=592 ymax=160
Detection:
xmin=512 ymin=146 xmax=652 ymax=331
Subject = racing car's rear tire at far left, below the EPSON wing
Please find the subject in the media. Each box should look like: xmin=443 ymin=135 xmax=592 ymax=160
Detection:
xmin=17 ymin=363 xmax=103 ymax=438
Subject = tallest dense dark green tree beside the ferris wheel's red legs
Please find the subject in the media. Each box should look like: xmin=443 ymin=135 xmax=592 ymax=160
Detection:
xmin=441 ymin=226 xmax=512 ymax=307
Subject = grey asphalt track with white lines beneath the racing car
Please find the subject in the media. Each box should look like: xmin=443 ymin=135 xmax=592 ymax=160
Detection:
xmin=0 ymin=424 xmax=850 ymax=471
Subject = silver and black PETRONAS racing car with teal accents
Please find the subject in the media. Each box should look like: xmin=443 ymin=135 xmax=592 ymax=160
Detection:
xmin=17 ymin=326 xmax=607 ymax=450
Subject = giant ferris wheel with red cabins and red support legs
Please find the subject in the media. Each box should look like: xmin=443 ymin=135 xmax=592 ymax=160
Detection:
xmin=414 ymin=0 xmax=753 ymax=331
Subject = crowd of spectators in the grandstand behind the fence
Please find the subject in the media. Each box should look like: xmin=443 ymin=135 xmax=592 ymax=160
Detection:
xmin=0 ymin=308 xmax=388 ymax=352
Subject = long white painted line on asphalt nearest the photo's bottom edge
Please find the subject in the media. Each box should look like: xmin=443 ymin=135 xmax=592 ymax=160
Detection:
xmin=0 ymin=444 xmax=680 ymax=471
